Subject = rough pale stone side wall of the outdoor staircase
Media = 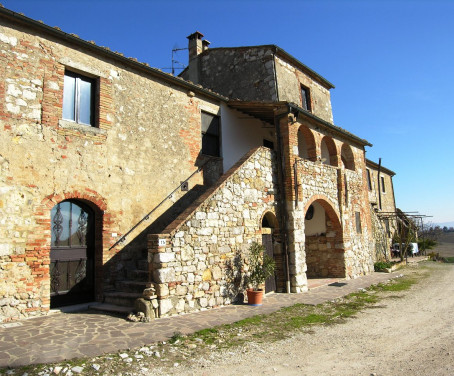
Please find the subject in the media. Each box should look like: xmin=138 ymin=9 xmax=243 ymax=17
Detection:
xmin=149 ymin=147 xmax=277 ymax=316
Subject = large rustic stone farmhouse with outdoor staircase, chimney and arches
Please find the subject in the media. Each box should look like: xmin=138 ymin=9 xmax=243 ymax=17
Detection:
xmin=0 ymin=8 xmax=398 ymax=321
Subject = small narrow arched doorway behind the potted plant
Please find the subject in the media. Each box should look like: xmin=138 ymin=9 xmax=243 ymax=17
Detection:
xmin=262 ymin=212 xmax=285 ymax=293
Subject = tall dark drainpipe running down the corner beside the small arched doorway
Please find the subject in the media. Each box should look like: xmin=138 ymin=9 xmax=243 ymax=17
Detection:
xmin=274 ymin=108 xmax=290 ymax=294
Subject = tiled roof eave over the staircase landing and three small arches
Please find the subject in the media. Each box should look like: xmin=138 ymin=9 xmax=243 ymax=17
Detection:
xmin=227 ymin=100 xmax=372 ymax=146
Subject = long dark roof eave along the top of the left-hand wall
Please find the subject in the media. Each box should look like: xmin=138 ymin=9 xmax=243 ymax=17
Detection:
xmin=0 ymin=7 xmax=227 ymax=101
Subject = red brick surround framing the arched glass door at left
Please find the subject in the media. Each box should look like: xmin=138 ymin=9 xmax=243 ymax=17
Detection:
xmin=22 ymin=188 xmax=113 ymax=312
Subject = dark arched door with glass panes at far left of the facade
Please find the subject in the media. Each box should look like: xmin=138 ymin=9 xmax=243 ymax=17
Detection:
xmin=50 ymin=200 xmax=95 ymax=308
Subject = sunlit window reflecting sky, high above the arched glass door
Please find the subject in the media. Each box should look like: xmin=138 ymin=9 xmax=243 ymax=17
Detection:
xmin=63 ymin=71 xmax=96 ymax=126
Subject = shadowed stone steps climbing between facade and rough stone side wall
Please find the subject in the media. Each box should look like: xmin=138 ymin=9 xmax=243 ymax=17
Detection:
xmin=90 ymin=185 xmax=208 ymax=315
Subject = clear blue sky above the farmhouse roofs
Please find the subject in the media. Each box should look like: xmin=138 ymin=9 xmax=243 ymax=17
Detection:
xmin=2 ymin=0 xmax=454 ymax=223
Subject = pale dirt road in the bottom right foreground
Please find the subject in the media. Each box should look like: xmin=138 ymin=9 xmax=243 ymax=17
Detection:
xmin=165 ymin=263 xmax=454 ymax=376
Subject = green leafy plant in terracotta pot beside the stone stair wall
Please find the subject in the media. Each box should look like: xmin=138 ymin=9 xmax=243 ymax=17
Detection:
xmin=247 ymin=242 xmax=275 ymax=305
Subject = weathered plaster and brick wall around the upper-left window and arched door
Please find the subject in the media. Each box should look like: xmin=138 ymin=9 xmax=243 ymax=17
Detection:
xmin=0 ymin=16 xmax=222 ymax=322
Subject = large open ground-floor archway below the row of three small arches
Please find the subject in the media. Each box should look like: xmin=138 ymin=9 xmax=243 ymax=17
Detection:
xmin=304 ymin=199 xmax=345 ymax=278
